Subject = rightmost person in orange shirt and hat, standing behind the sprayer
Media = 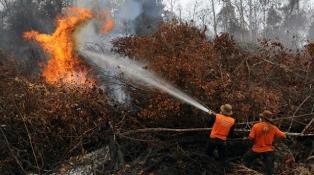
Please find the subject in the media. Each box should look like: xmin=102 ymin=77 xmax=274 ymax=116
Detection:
xmin=243 ymin=110 xmax=286 ymax=175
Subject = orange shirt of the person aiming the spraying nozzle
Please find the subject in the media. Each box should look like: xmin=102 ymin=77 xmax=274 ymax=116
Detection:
xmin=210 ymin=114 xmax=235 ymax=140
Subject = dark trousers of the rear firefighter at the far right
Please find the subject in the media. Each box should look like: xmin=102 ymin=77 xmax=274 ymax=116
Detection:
xmin=243 ymin=150 xmax=274 ymax=175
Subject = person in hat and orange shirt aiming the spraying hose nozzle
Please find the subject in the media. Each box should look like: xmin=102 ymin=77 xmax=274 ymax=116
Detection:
xmin=207 ymin=104 xmax=235 ymax=166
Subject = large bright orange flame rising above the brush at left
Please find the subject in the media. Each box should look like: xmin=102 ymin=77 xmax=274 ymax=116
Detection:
xmin=23 ymin=8 xmax=94 ymax=85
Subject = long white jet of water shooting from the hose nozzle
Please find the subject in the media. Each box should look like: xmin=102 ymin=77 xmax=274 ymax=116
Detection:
xmin=79 ymin=49 xmax=209 ymax=112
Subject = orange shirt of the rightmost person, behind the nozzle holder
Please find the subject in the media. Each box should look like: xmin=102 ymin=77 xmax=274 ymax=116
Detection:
xmin=249 ymin=122 xmax=286 ymax=153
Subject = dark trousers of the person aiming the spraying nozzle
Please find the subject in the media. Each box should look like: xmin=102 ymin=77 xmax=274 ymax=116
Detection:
xmin=206 ymin=138 xmax=226 ymax=165
